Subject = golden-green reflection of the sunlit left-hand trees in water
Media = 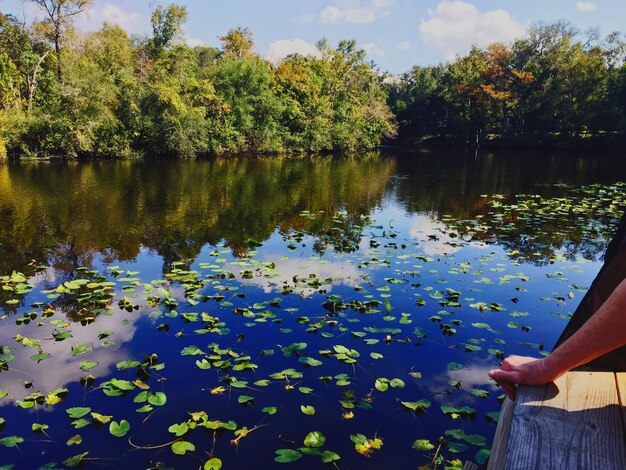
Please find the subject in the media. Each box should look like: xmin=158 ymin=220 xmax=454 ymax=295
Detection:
xmin=0 ymin=155 xmax=395 ymax=274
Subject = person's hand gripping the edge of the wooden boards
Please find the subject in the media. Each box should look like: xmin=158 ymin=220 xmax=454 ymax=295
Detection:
xmin=489 ymin=356 xmax=560 ymax=400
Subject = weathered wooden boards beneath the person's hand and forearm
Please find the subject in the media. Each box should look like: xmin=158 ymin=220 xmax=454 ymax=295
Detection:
xmin=504 ymin=372 xmax=626 ymax=470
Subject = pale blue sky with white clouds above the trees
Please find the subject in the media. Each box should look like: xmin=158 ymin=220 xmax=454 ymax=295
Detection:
xmin=0 ymin=0 xmax=626 ymax=73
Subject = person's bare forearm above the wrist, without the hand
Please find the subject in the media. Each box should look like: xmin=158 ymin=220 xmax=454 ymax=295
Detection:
xmin=544 ymin=279 xmax=626 ymax=375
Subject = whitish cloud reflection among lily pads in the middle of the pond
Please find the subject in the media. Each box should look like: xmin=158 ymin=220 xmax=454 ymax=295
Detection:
xmin=229 ymin=253 xmax=364 ymax=297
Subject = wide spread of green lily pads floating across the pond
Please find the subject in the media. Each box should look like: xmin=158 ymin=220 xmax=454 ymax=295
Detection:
xmin=0 ymin=184 xmax=626 ymax=469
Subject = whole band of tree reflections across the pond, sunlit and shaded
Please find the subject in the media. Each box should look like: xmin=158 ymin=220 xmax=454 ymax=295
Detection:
xmin=0 ymin=152 xmax=626 ymax=279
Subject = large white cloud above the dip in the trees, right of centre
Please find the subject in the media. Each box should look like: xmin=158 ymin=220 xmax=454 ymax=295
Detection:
xmin=419 ymin=0 xmax=527 ymax=60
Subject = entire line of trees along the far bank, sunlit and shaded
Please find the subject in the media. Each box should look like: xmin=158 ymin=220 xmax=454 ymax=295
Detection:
xmin=0 ymin=0 xmax=626 ymax=159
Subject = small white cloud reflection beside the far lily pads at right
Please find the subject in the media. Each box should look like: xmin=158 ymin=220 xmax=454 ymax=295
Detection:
xmin=408 ymin=215 xmax=487 ymax=256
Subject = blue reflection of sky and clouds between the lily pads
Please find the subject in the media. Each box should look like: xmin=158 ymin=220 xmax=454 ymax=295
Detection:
xmin=0 ymin=190 xmax=599 ymax=468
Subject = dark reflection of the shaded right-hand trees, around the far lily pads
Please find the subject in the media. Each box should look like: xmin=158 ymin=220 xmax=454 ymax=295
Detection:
xmin=393 ymin=152 xmax=626 ymax=264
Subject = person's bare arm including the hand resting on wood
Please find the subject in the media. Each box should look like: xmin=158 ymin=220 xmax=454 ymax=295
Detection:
xmin=489 ymin=279 xmax=626 ymax=400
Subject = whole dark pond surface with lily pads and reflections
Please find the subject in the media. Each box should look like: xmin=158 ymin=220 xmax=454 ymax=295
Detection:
xmin=0 ymin=152 xmax=626 ymax=469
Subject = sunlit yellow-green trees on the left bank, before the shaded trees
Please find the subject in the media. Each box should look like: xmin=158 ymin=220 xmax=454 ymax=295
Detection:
xmin=0 ymin=0 xmax=394 ymax=158
